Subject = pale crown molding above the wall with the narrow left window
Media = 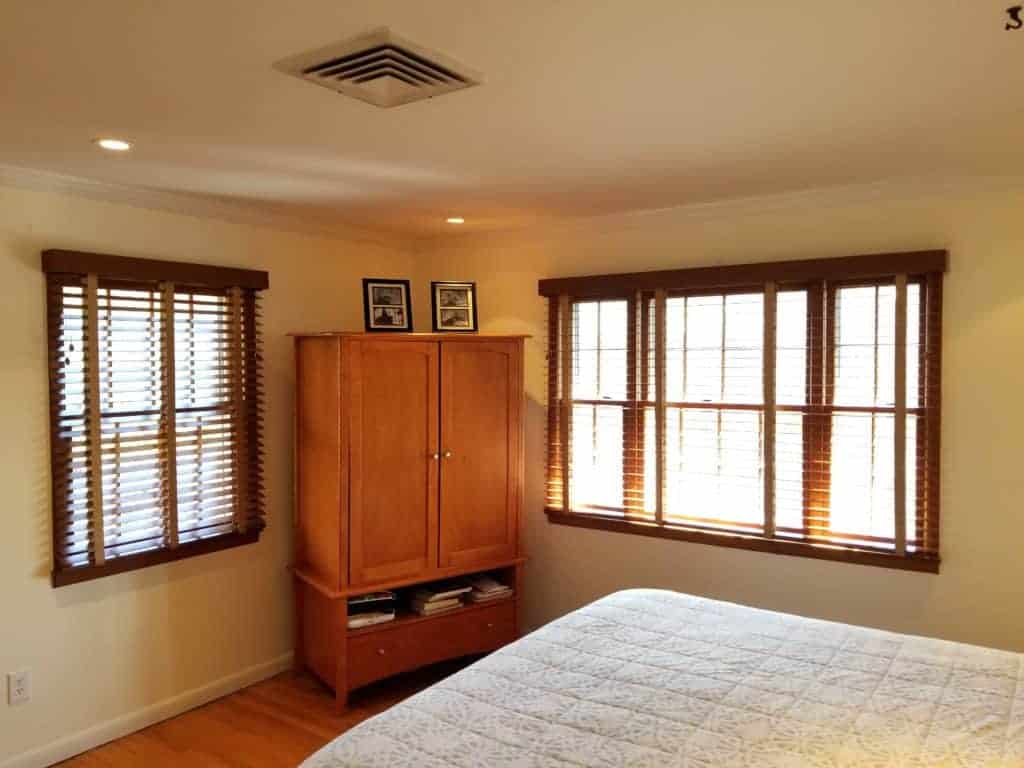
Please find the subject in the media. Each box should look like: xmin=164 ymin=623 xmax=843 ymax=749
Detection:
xmin=0 ymin=164 xmax=411 ymax=249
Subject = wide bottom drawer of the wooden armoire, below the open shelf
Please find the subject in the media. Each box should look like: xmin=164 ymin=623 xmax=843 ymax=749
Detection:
xmin=348 ymin=600 xmax=515 ymax=690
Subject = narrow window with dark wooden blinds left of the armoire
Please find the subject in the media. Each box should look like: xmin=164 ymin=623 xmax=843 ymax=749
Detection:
xmin=43 ymin=251 xmax=267 ymax=586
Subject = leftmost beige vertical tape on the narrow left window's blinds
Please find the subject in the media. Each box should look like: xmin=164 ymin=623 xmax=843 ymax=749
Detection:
xmin=85 ymin=272 xmax=106 ymax=565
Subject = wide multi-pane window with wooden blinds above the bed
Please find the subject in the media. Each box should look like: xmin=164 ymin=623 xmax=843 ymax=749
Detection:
xmin=540 ymin=252 xmax=946 ymax=570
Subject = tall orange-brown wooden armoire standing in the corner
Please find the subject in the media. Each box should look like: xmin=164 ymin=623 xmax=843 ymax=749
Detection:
xmin=293 ymin=333 xmax=524 ymax=707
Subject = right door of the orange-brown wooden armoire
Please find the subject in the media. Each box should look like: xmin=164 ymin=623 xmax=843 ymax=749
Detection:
xmin=439 ymin=340 xmax=522 ymax=567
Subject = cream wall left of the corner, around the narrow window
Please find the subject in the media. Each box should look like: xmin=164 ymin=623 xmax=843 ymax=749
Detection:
xmin=0 ymin=187 xmax=411 ymax=765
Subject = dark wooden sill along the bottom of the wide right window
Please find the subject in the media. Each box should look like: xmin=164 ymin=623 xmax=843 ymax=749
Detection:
xmin=545 ymin=508 xmax=939 ymax=573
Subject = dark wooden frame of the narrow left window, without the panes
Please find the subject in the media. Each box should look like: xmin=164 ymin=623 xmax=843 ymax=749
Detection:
xmin=42 ymin=250 xmax=269 ymax=587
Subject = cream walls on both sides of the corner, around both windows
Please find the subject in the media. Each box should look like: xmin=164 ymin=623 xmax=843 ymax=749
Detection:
xmin=0 ymin=176 xmax=1024 ymax=768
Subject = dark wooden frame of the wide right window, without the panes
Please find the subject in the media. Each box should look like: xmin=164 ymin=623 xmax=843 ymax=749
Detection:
xmin=539 ymin=251 xmax=948 ymax=573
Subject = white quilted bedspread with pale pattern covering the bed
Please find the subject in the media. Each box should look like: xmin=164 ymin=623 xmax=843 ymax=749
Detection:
xmin=304 ymin=590 xmax=1024 ymax=768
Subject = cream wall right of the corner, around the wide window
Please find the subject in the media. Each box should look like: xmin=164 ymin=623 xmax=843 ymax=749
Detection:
xmin=417 ymin=185 xmax=1024 ymax=650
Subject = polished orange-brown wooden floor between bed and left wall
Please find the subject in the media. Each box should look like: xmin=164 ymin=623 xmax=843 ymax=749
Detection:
xmin=59 ymin=660 xmax=468 ymax=768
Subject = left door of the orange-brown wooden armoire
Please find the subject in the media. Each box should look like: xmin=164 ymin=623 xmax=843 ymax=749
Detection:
xmin=347 ymin=339 xmax=440 ymax=586
